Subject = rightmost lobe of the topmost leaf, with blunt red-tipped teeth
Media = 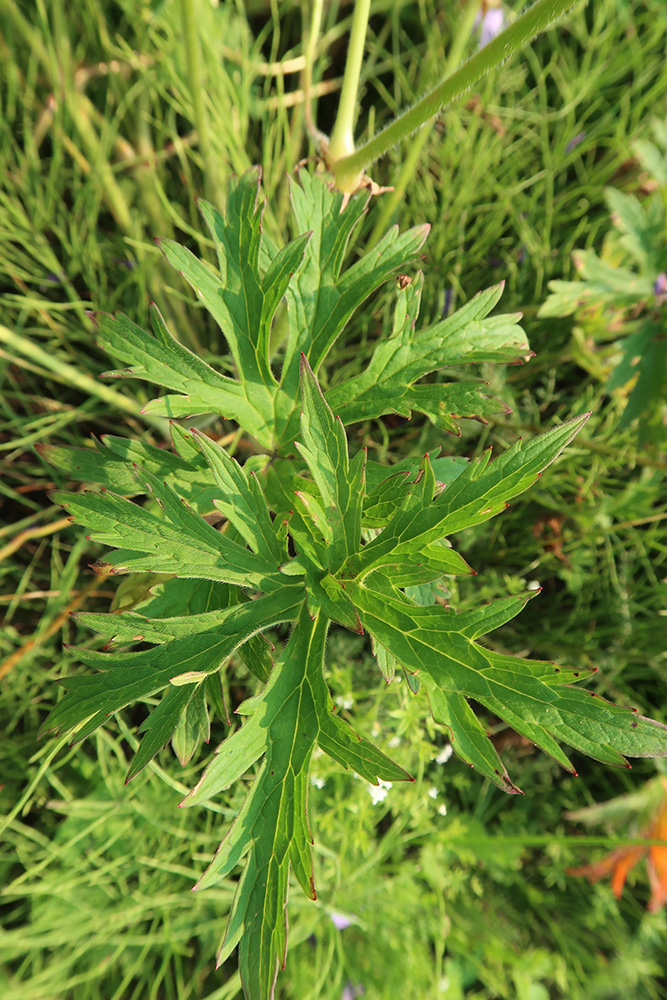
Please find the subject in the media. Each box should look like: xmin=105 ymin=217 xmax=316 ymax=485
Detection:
xmin=326 ymin=271 xmax=530 ymax=433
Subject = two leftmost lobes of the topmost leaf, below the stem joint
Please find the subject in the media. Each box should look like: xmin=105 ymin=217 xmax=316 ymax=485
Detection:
xmin=96 ymin=170 xmax=310 ymax=447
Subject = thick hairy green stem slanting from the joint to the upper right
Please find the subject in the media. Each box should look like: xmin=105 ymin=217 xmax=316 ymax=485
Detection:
xmin=330 ymin=0 xmax=578 ymax=192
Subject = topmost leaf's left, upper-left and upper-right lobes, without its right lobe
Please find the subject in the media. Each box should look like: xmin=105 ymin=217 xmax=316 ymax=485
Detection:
xmin=85 ymin=170 xmax=429 ymax=453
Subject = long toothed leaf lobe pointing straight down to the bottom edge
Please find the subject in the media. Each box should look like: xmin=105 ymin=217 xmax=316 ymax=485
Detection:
xmin=182 ymin=609 xmax=409 ymax=1000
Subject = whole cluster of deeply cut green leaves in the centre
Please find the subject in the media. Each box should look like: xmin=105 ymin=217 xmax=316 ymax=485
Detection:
xmin=43 ymin=172 xmax=667 ymax=1000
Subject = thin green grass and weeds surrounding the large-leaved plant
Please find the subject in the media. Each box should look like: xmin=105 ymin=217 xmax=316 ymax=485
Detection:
xmin=0 ymin=0 xmax=667 ymax=1000
